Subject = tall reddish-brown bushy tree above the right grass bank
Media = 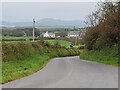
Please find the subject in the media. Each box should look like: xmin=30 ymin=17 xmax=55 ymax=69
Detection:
xmin=84 ymin=2 xmax=120 ymax=50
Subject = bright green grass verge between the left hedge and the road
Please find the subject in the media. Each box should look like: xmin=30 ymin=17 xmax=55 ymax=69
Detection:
xmin=2 ymin=55 xmax=50 ymax=83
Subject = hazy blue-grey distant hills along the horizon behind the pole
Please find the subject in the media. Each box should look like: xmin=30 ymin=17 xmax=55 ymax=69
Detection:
xmin=2 ymin=18 xmax=86 ymax=27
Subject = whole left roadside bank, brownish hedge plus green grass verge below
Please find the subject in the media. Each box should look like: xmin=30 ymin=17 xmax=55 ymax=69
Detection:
xmin=0 ymin=42 xmax=80 ymax=83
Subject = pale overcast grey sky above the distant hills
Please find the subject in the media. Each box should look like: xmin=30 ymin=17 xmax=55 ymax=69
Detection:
xmin=0 ymin=2 xmax=96 ymax=22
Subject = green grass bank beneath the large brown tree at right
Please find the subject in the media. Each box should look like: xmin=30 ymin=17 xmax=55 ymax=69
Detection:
xmin=80 ymin=45 xmax=120 ymax=66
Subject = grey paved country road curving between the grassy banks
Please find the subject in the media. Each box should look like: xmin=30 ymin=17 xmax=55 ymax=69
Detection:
xmin=3 ymin=56 xmax=118 ymax=88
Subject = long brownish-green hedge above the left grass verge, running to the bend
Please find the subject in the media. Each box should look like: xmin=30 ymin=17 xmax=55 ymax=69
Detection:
xmin=2 ymin=42 xmax=78 ymax=61
